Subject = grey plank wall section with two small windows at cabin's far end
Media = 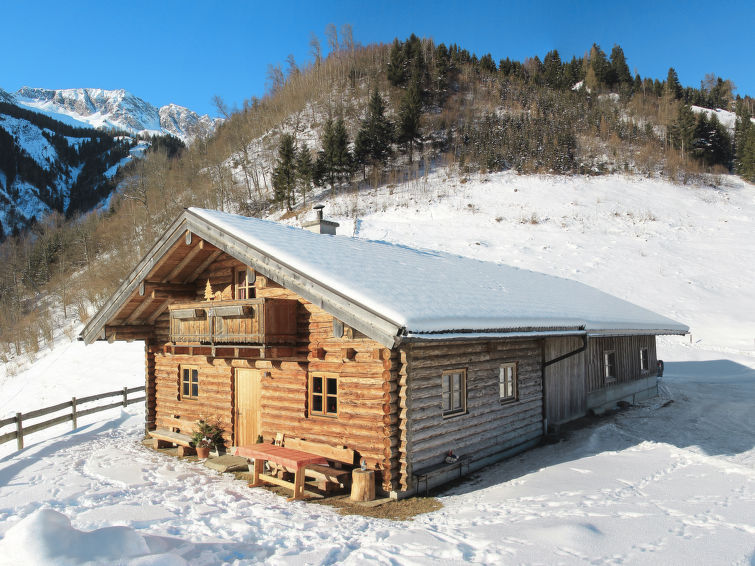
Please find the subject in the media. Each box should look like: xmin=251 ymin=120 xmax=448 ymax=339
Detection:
xmin=586 ymin=336 xmax=658 ymax=393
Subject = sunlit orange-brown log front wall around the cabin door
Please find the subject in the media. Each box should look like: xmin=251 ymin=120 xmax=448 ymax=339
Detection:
xmin=148 ymin=254 xmax=399 ymax=492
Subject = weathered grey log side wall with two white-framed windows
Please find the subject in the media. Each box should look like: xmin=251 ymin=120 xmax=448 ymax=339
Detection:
xmin=400 ymin=340 xmax=543 ymax=489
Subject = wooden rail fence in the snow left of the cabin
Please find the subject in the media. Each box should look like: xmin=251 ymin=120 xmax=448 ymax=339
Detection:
xmin=0 ymin=385 xmax=146 ymax=450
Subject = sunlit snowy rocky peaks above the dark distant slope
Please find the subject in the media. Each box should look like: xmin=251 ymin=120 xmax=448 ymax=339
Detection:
xmin=14 ymin=87 xmax=221 ymax=143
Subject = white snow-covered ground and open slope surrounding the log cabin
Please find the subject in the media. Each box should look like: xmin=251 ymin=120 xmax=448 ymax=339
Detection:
xmin=0 ymin=174 xmax=755 ymax=565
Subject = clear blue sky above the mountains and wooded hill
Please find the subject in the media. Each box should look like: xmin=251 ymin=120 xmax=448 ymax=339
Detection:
xmin=0 ymin=0 xmax=755 ymax=114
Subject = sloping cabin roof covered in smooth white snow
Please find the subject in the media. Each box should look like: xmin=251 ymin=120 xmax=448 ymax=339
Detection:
xmin=188 ymin=208 xmax=689 ymax=338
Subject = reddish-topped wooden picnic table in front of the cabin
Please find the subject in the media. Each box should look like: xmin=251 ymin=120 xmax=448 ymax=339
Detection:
xmin=236 ymin=444 xmax=328 ymax=501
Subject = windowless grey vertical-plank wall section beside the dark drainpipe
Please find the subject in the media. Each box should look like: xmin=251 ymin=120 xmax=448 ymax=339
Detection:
xmin=543 ymin=336 xmax=587 ymax=424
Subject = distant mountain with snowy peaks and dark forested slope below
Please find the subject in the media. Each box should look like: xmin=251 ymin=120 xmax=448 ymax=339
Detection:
xmin=0 ymin=87 xmax=221 ymax=239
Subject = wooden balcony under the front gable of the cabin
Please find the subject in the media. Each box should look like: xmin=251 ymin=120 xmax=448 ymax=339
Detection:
xmin=170 ymin=299 xmax=298 ymax=346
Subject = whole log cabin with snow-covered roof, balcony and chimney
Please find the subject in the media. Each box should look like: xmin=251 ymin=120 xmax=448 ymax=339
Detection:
xmin=80 ymin=208 xmax=688 ymax=498
